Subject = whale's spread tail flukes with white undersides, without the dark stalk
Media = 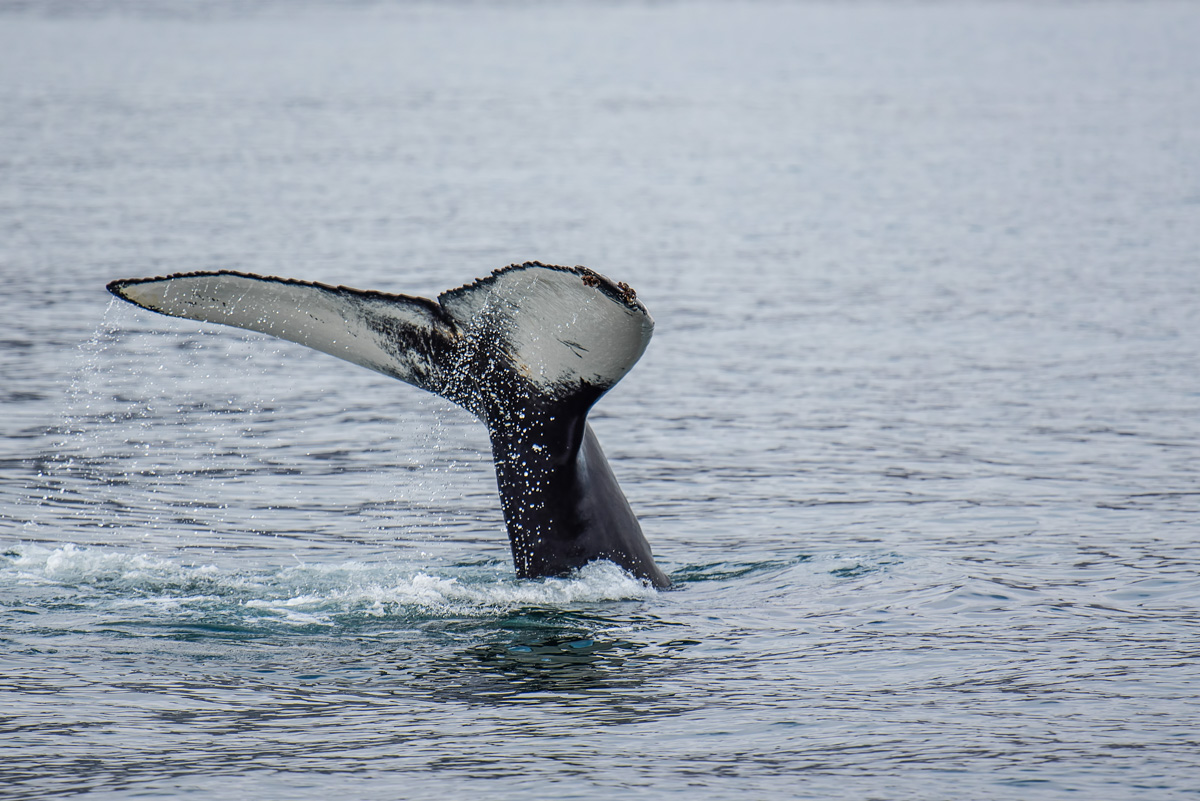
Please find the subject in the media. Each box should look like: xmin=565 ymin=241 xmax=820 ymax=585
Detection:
xmin=109 ymin=263 xmax=654 ymax=396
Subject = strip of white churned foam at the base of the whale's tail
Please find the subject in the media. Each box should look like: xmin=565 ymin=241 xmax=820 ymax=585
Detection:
xmin=0 ymin=543 xmax=656 ymax=626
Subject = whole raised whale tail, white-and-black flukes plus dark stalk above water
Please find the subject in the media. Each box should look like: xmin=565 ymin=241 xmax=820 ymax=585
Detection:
xmin=108 ymin=261 xmax=671 ymax=588
